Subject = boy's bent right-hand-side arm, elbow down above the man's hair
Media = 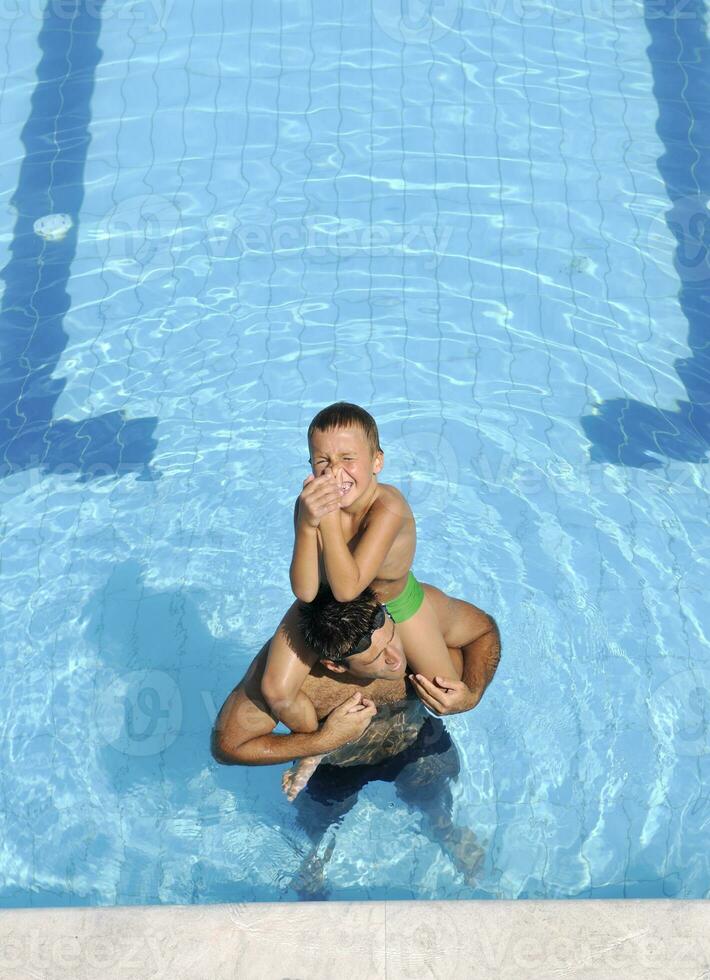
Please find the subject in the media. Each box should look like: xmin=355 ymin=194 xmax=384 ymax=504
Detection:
xmin=320 ymin=504 xmax=411 ymax=602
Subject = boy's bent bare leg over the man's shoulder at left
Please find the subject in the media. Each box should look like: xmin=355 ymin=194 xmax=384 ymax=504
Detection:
xmin=261 ymin=602 xmax=318 ymax=732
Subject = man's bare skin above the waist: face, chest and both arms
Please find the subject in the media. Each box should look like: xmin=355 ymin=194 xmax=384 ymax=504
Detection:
xmin=213 ymin=583 xmax=500 ymax=780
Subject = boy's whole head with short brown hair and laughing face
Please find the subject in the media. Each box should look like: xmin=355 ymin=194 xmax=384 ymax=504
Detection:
xmin=308 ymin=402 xmax=384 ymax=510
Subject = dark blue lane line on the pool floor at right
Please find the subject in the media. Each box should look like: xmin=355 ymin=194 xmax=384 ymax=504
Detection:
xmin=581 ymin=0 xmax=710 ymax=469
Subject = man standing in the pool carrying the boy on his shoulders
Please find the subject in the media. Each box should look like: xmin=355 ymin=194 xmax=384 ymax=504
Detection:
xmin=212 ymin=583 xmax=500 ymax=897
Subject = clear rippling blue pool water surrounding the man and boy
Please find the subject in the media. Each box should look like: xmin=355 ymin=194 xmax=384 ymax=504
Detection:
xmin=0 ymin=0 xmax=710 ymax=906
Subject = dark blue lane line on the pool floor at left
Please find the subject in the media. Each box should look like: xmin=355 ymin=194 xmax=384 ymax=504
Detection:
xmin=0 ymin=0 xmax=157 ymax=482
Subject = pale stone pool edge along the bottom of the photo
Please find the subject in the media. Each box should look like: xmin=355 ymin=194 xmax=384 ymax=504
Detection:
xmin=0 ymin=899 xmax=710 ymax=980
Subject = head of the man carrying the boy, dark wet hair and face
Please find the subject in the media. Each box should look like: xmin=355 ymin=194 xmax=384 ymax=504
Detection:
xmin=300 ymin=587 xmax=407 ymax=680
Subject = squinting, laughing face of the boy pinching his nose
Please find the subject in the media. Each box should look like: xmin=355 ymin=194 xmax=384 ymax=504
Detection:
xmin=309 ymin=426 xmax=384 ymax=507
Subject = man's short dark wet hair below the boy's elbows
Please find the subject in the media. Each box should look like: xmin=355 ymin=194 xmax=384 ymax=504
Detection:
xmin=299 ymin=586 xmax=379 ymax=664
